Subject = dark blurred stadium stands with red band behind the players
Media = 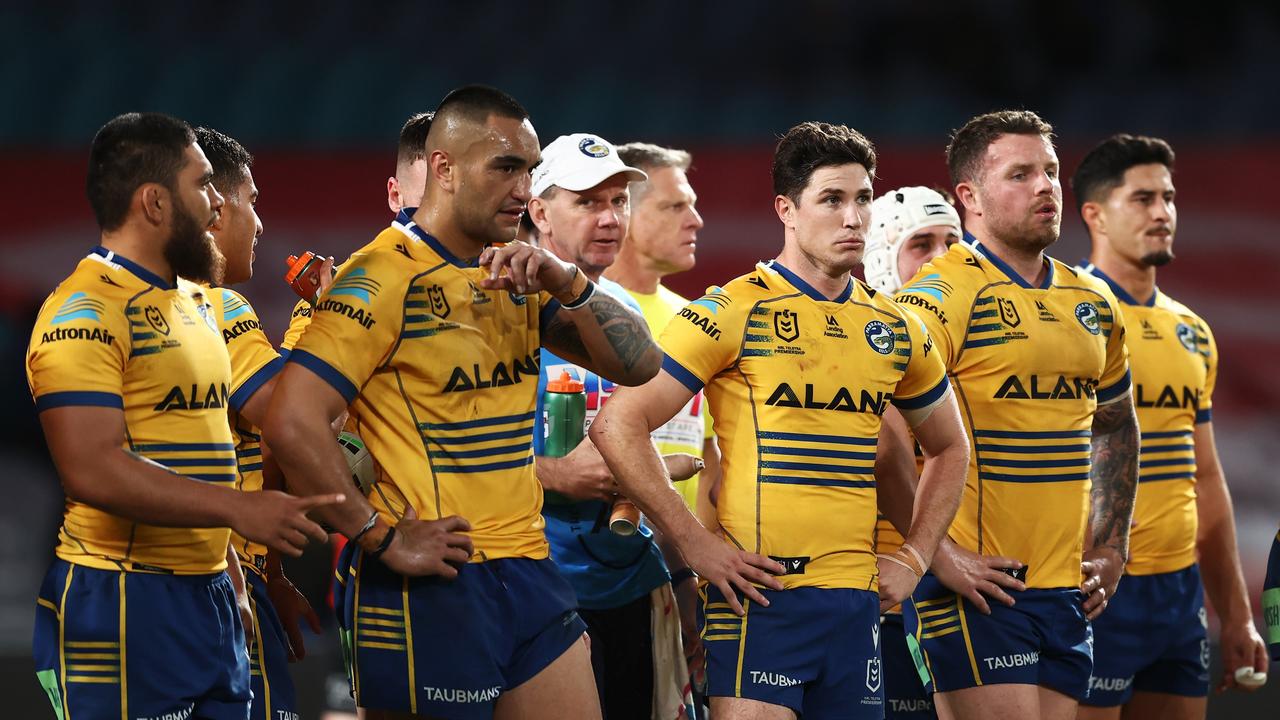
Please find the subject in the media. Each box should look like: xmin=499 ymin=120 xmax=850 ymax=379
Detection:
xmin=0 ymin=0 xmax=1280 ymax=719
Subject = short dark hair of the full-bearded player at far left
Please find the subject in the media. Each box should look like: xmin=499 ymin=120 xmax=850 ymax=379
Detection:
xmin=84 ymin=113 xmax=196 ymax=231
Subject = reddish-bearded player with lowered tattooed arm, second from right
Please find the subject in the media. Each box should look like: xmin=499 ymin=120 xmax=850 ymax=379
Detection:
xmin=897 ymin=111 xmax=1138 ymax=719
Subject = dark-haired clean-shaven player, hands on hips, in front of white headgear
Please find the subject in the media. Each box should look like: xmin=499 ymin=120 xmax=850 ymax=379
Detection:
xmin=590 ymin=123 xmax=968 ymax=720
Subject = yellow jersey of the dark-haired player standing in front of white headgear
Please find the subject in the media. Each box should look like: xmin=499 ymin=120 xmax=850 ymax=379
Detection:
xmin=660 ymin=261 xmax=947 ymax=591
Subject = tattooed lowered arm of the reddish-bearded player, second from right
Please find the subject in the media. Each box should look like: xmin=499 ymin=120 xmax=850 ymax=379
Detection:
xmin=1089 ymin=398 xmax=1138 ymax=557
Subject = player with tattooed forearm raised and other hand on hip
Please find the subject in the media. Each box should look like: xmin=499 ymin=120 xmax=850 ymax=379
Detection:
xmin=264 ymin=86 xmax=659 ymax=719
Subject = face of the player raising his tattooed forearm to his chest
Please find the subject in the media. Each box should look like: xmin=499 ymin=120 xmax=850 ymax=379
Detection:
xmin=452 ymin=115 xmax=540 ymax=243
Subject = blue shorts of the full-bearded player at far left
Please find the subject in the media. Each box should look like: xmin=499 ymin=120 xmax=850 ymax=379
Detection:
xmin=32 ymin=560 xmax=250 ymax=720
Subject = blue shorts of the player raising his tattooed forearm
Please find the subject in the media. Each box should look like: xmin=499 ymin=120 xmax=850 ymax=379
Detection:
xmin=344 ymin=551 xmax=586 ymax=719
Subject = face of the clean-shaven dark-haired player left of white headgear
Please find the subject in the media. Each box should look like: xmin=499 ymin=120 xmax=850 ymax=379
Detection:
xmin=783 ymin=163 xmax=872 ymax=275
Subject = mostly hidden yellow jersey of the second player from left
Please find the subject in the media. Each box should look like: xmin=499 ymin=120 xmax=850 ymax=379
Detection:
xmin=205 ymin=287 xmax=284 ymax=575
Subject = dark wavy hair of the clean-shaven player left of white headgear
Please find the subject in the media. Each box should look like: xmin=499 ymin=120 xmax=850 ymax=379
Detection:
xmin=772 ymin=122 xmax=876 ymax=202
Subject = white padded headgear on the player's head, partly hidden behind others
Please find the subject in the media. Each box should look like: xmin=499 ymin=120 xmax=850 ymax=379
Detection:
xmin=863 ymin=186 xmax=964 ymax=293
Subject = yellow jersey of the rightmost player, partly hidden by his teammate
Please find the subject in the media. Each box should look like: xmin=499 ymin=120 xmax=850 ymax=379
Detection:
xmin=1084 ymin=265 xmax=1217 ymax=575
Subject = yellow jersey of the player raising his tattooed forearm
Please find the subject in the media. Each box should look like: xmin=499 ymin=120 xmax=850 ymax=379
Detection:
xmin=288 ymin=213 xmax=559 ymax=561
